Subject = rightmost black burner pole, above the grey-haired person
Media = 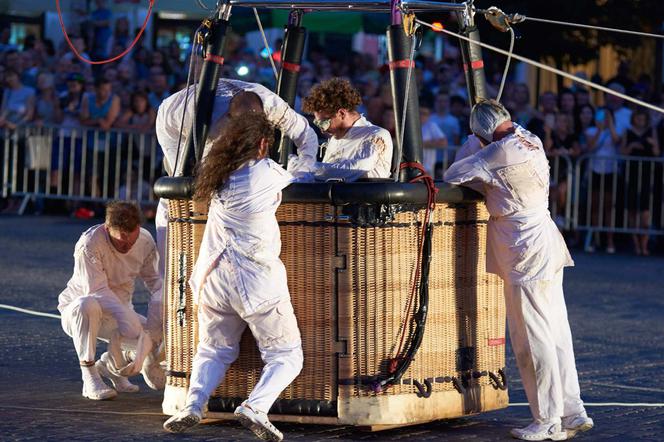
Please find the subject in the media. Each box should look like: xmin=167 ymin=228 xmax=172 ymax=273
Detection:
xmin=457 ymin=1 xmax=488 ymax=107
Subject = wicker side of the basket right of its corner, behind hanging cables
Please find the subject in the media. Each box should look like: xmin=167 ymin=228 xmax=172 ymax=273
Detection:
xmin=338 ymin=204 xmax=505 ymax=397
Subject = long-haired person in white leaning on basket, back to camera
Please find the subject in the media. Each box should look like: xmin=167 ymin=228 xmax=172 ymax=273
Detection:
xmin=164 ymin=113 xmax=302 ymax=441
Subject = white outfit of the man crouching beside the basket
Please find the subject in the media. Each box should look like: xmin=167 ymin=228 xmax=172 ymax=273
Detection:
xmin=58 ymin=224 xmax=162 ymax=361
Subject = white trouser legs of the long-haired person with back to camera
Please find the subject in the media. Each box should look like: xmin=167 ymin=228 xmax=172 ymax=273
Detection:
xmin=187 ymin=273 xmax=303 ymax=413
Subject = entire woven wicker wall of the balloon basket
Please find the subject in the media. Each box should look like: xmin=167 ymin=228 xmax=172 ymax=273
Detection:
xmin=166 ymin=201 xmax=505 ymax=414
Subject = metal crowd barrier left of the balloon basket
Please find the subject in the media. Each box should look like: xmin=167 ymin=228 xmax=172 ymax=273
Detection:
xmin=0 ymin=125 xmax=162 ymax=213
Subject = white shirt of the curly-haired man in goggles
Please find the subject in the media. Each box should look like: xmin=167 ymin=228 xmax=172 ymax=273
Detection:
xmin=316 ymin=116 xmax=393 ymax=180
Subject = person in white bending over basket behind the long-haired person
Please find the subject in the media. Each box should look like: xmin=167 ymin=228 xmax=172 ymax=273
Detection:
xmin=155 ymin=79 xmax=318 ymax=276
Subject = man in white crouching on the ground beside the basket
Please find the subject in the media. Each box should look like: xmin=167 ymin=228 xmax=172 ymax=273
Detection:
xmin=58 ymin=201 xmax=166 ymax=400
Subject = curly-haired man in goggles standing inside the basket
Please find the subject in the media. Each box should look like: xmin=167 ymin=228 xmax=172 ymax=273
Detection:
xmin=303 ymin=78 xmax=392 ymax=180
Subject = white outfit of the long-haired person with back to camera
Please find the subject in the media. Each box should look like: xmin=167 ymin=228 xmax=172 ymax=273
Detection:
xmin=187 ymin=159 xmax=303 ymax=413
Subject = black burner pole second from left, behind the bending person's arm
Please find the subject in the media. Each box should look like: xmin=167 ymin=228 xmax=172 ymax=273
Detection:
xmin=270 ymin=9 xmax=307 ymax=167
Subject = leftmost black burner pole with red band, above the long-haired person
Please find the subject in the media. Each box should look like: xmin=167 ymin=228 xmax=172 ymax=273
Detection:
xmin=176 ymin=2 xmax=231 ymax=176
